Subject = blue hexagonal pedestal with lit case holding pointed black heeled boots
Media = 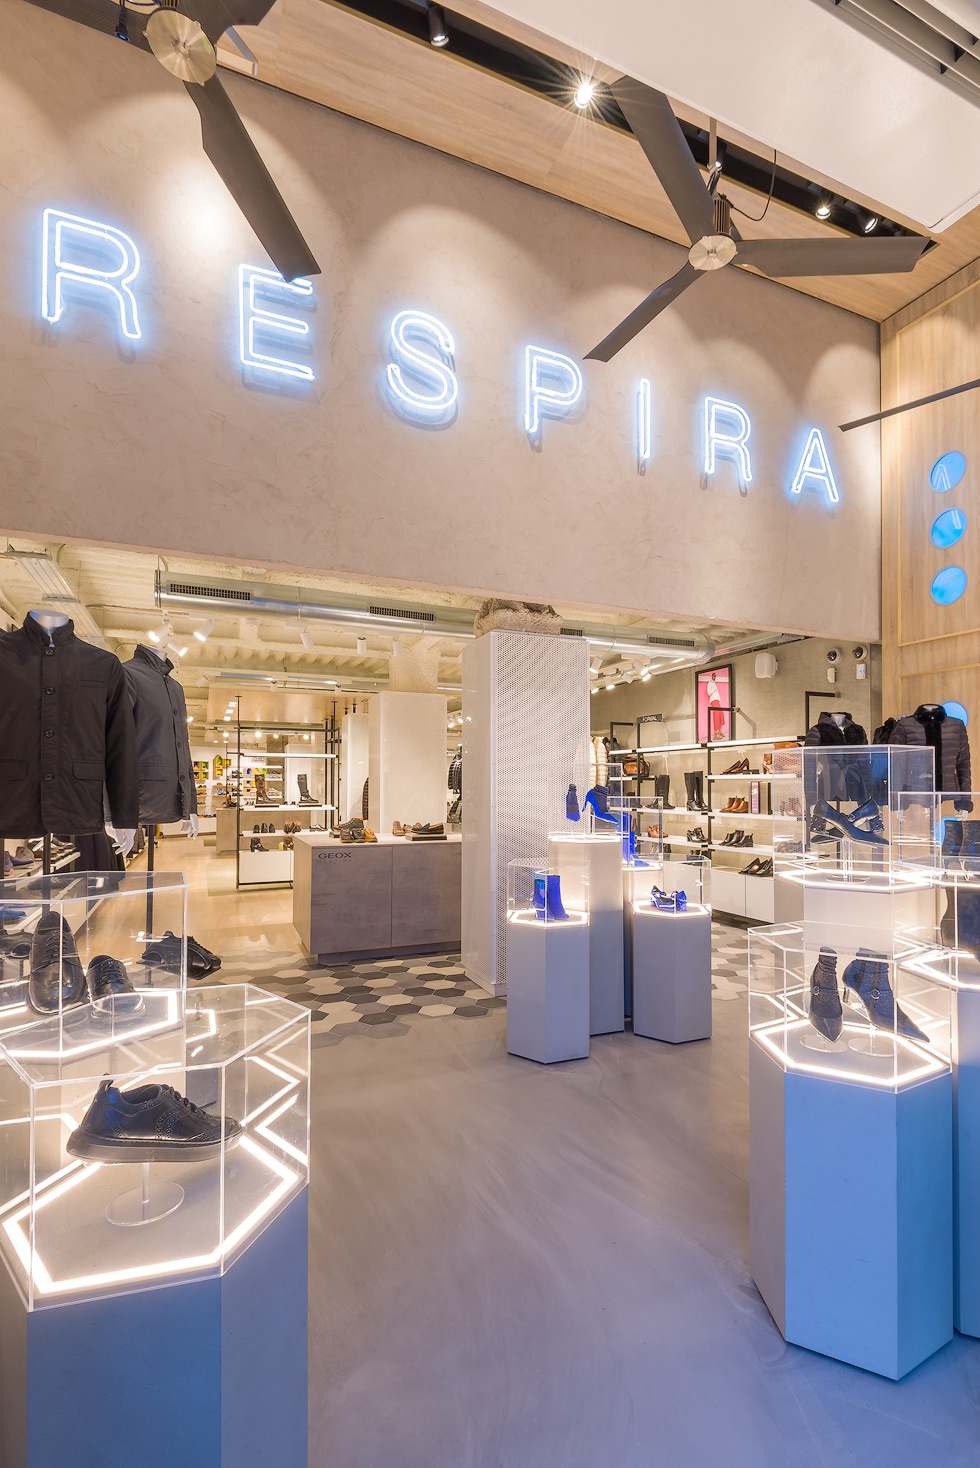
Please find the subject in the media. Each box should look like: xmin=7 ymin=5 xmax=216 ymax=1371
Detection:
xmin=748 ymin=922 xmax=954 ymax=1380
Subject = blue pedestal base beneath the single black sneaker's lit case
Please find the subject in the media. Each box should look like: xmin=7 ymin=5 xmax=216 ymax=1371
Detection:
xmin=0 ymin=1189 xmax=308 ymax=1468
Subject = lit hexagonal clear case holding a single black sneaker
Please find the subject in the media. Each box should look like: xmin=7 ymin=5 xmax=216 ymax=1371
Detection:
xmin=0 ymin=984 xmax=310 ymax=1309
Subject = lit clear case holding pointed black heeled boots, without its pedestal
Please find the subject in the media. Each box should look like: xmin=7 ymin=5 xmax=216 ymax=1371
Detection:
xmin=748 ymin=922 xmax=952 ymax=1089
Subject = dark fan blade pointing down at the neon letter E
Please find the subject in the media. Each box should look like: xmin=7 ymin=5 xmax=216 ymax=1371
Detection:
xmin=183 ymin=76 xmax=320 ymax=280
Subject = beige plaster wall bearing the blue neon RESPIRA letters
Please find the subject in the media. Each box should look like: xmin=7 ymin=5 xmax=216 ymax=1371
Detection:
xmin=0 ymin=0 xmax=880 ymax=640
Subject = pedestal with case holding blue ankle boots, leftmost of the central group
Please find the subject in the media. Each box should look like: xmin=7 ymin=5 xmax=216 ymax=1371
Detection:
xmin=506 ymin=843 xmax=586 ymax=1064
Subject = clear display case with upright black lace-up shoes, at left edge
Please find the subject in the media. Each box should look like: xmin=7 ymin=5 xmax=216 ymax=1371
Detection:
xmin=0 ymin=872 xmax=188 ymax=1035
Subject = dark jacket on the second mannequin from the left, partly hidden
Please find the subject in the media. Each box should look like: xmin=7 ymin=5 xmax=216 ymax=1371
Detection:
xmin=123 ymin=646 xmax=198 ymax=824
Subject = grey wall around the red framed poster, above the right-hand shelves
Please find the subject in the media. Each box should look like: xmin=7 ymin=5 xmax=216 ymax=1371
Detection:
xmin=591 ymin=637 xmax=882 ymax=772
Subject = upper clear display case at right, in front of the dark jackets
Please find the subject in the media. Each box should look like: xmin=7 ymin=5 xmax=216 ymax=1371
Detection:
xmin=773 ymin=744 xmax=935 ymax=890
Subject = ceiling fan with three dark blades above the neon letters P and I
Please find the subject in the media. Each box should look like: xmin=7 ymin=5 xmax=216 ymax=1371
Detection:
xmin=587 ymin=76 xmax=929 ymax=363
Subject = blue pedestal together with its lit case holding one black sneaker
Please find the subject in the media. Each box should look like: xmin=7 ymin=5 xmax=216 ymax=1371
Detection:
xmin=0 ymin=985 xmax=310 ymax=1468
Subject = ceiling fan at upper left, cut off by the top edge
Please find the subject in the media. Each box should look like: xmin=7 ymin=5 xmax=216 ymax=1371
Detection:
xmin=22 ymin=0 xmax=320 ymax=280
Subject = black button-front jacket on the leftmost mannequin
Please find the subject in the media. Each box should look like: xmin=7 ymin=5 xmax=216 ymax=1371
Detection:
xmin=0 ymin=615 xmax=139 ymax=837
